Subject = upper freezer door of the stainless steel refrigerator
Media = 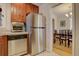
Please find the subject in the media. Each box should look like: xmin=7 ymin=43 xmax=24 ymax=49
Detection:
xmin=32 ymin=14 xmax=46 ymax=27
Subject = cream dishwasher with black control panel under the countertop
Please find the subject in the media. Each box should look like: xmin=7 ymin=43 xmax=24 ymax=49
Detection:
xmin=8 ymin=35 xmax=27 ymax=56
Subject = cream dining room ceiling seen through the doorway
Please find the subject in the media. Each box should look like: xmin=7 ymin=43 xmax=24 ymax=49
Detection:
xmin=52 ymin=3 xmax=72 ymax=14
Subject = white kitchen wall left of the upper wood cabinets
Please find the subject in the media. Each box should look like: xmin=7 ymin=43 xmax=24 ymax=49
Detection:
xmin=0 ymin=3 xmax=11 ymax=33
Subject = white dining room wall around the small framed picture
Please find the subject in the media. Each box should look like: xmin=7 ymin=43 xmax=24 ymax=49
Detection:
xmin=54 ymin=14 xmax=72 ymax=30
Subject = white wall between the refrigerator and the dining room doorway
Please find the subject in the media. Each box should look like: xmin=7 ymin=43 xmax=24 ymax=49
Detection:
xmin=39 ymin=5 xmax=53 ymax=51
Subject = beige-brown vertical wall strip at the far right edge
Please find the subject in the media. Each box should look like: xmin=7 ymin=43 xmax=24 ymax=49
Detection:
xmin=72 ymin=3 xmax=79 ymax=56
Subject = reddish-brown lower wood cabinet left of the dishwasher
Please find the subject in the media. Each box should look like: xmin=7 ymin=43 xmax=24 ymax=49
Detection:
xmin=0 ymin=36 xmax=8 ymax=56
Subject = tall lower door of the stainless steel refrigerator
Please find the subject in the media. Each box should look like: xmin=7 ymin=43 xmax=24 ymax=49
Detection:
xmin=31 ymin=28 xmax=45 ymax=55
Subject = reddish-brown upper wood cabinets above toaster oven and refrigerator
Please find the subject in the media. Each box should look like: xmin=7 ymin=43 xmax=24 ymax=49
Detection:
xmin=11 ymin=3 xmax=39 ymax=22
